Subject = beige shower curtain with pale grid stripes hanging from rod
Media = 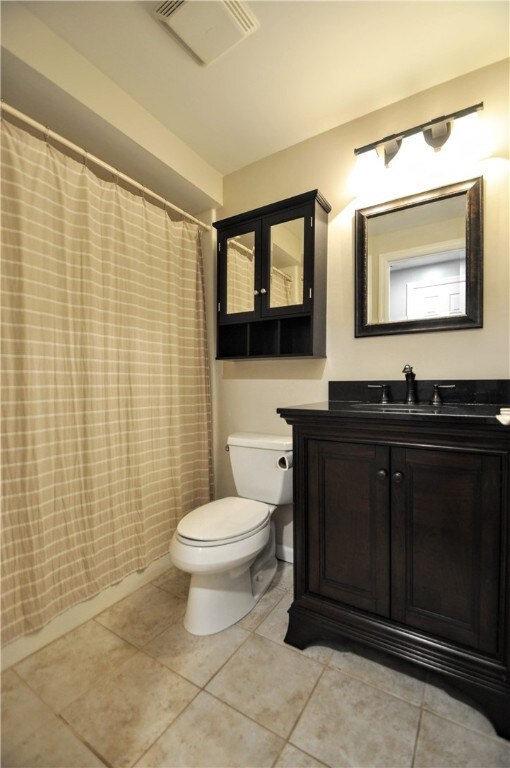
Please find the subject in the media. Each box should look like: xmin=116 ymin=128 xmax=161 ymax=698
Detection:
xmin=2 ymin=119 xmax=212 ymax=642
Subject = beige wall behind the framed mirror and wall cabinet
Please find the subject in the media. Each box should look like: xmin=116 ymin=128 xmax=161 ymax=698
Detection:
xmin=212 ymin=60 xmax=510 ymax=495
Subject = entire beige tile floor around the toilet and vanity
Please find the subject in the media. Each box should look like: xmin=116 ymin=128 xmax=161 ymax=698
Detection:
xmin=2 ymin=563 xmax=510 ymax=768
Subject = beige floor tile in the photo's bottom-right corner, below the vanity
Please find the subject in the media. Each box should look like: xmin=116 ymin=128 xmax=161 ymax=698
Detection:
xmin=414 ymin=712 xmax=510 ymax=768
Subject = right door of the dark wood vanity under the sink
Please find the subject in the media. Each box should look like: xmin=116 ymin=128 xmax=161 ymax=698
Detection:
xmin=391 ymin=448 xmax=501 ymax=653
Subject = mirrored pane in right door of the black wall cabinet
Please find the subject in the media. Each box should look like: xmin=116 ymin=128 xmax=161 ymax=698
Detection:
xmin=269 ymin=218 xmax=305 ymax=307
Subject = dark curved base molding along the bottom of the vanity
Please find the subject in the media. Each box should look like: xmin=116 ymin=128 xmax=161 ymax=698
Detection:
xmin=285 ymin=595 xmax=510 ymax=739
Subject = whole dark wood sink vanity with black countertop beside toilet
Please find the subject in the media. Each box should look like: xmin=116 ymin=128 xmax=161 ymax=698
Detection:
xmin=278 ymin=382 xmax=510 ymax=738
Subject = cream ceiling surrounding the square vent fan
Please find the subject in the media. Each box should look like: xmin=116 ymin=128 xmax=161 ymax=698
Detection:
xmin=0 ymin=0 xmax=509 ymax=210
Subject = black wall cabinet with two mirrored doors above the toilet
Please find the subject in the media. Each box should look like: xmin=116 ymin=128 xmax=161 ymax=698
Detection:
xmin=214 ymin=190 xmax=331 ymax=359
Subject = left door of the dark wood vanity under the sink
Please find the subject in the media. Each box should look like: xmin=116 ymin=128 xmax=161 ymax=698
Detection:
xmin=308 ymin=441 xmax=389 ymax=615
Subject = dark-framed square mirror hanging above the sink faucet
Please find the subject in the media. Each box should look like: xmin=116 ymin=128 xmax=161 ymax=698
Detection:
xmin=355 ymin=178 xmax=483 ymax=336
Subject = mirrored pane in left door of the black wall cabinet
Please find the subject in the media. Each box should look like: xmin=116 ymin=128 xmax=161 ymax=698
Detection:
xmin=227 ymin=232 xmax=255 ymax=315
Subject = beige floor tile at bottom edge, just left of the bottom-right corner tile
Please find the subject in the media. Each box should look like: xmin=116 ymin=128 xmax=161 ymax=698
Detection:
xmin=290 ymin=668 xmax=420 ymax=768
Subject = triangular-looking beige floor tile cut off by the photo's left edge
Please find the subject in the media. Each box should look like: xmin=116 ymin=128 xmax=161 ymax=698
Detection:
xmin=2 ymin=669 xmax=55 ymax=765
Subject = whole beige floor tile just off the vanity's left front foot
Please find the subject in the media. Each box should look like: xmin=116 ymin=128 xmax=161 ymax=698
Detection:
xmin=207 ymin=635 xmax=324 ymax=737
